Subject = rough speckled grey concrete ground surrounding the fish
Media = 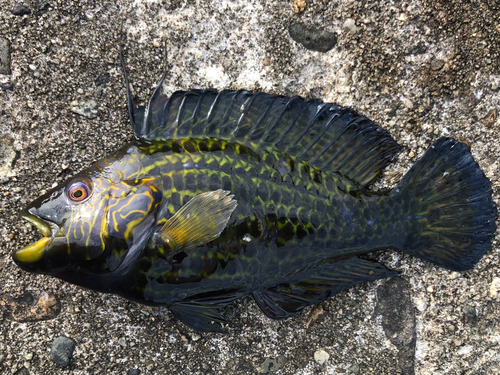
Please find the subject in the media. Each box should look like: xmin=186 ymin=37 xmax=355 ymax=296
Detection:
xmin=0 ymin=0 xmax=500 ymax=375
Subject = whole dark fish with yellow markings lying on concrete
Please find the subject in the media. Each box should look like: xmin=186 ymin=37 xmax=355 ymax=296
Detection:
xmin=12 ymin=44 xmax=497 ymax=333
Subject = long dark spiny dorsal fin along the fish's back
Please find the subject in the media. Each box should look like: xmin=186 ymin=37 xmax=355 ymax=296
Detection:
xmin=134 ymin=90 xmax=399 ymax=187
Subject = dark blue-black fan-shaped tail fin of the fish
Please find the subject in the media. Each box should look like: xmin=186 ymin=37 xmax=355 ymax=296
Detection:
xmin=391 ymin=138 xmax=497 ymax=271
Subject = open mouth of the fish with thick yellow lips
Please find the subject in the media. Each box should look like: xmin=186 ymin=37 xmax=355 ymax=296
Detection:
xmin=12 ymin=212 xmax=63 ymax=263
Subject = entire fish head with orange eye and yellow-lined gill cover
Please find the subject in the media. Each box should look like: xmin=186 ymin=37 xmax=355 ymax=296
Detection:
xmin=12 ymin=156 xmax=162 ymax=277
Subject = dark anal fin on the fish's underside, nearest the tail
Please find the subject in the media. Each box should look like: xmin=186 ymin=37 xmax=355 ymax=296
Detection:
xmin=252 ymin=258 xmax=398 ymax=319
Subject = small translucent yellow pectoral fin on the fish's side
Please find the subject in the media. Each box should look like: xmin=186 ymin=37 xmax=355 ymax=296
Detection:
xmin=158 ymin=189 xmax=237 ymax=250
